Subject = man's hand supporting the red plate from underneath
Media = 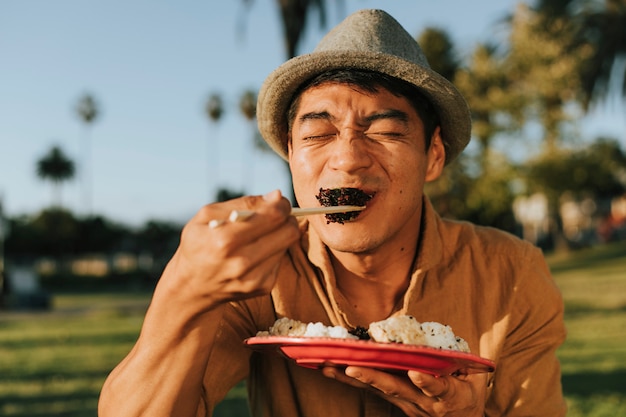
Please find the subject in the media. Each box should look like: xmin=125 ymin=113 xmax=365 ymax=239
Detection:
xmin=322 ymin=366 xmax=487 ymax=417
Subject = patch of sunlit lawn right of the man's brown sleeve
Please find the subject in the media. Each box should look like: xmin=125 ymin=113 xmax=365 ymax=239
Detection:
xmin=548 ymin=242 xmax=626 ymax=417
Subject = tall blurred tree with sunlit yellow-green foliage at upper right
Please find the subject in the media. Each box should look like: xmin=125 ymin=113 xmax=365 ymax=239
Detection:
xmin=510 ymin=0 xmax=623 ymax=249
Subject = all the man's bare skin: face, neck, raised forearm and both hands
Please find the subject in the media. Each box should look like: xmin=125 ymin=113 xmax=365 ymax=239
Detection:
xmin=98 ymin=85 xmax=486 ymax=417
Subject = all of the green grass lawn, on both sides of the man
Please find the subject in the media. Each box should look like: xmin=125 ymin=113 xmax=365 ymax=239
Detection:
xmin=0 ymin=242 xmax=626 ymax=417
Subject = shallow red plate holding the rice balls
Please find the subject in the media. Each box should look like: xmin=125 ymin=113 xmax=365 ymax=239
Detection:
xmin=244 ymin=336 xmax=496 ymax=375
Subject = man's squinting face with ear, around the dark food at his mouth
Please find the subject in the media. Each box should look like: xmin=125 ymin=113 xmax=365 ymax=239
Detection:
xmin=289 ymin=83 xmax=445 ymax=253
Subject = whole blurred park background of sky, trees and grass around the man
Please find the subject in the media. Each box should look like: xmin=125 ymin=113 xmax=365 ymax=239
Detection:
xmin=0 ymin=0 xmax=626 ymax=416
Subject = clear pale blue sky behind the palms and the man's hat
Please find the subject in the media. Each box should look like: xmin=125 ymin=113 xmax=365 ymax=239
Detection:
xmin=0 ymin=0 xmax=626 ymax=225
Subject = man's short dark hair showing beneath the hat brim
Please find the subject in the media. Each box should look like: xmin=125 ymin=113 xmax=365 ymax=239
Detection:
xmin=287 ymin=68 xmax=439 ymax=149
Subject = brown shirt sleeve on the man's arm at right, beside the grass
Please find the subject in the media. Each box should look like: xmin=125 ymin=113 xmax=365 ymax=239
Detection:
xmin=485 ymin=245 xmax=566 ymax=417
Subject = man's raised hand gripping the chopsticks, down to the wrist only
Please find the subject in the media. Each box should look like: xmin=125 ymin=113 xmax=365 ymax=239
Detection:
xmin=155 ymin=191 xmax=300 ymax=313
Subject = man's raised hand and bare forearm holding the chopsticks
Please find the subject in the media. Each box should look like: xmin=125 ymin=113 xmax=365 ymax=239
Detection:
xmin=99 ymin=191 xmax=300 ymax=417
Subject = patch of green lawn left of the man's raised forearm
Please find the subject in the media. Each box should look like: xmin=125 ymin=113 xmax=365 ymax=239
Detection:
xmin=0 ymin=294 xmax=149 ymax=417
